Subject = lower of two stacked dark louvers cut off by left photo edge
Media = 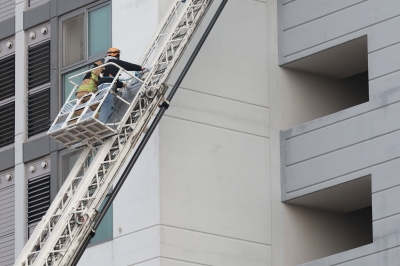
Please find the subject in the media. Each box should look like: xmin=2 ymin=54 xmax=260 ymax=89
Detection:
xmin=0 ymin=102 xmax=15 ymax=147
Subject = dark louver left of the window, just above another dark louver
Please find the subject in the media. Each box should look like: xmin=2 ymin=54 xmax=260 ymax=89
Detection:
xmin=28 ymin=41 xmax=50 ymax=90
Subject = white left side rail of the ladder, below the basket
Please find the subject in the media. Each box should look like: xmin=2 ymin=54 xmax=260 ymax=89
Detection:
xmin=15 ymin=148 xmax=90 ymax=265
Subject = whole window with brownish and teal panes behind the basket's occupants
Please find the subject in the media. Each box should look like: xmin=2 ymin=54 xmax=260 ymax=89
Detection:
xmin=60 ymin=3 xmax=111 ymax=105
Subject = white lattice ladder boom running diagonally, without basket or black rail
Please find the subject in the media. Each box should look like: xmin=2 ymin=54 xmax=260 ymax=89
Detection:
xmin=14 ymin=0 xmax=212 ymax=266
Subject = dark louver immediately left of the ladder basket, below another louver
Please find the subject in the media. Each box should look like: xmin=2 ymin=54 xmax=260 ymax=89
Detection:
xmin=28 ymin=88 xmax=50 ymax=137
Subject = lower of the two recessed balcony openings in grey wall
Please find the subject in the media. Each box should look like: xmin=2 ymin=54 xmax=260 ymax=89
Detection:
xmin=285 ymin=175 xmax=373 ymax=266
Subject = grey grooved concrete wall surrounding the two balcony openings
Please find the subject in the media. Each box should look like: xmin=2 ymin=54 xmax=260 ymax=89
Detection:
xmin=278 ymin=0 xmax=400 ymax=265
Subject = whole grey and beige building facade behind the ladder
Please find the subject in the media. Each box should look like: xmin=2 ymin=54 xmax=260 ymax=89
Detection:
xmin=0 ymin=0 xmax=400 ymax=266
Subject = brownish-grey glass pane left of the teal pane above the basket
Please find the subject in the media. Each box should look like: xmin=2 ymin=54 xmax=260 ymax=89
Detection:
xmin=63 ymin=14 xmax=85 ymax=67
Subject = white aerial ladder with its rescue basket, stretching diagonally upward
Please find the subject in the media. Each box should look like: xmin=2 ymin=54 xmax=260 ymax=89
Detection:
xmin=14 ymin=0 xmax=227 ymax=266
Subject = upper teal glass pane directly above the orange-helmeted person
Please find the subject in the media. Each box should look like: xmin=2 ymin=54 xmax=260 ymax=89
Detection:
xmin=88 ymin=5 xmax=111 ymax=56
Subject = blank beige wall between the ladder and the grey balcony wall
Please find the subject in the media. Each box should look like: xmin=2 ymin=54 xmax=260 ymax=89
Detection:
xmin=160 ymin=0 xmax=272 ymax=266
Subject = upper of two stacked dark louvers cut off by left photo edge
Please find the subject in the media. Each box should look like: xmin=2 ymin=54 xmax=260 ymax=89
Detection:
xmin=0 ymin=55 xmax=15 ymax=101
